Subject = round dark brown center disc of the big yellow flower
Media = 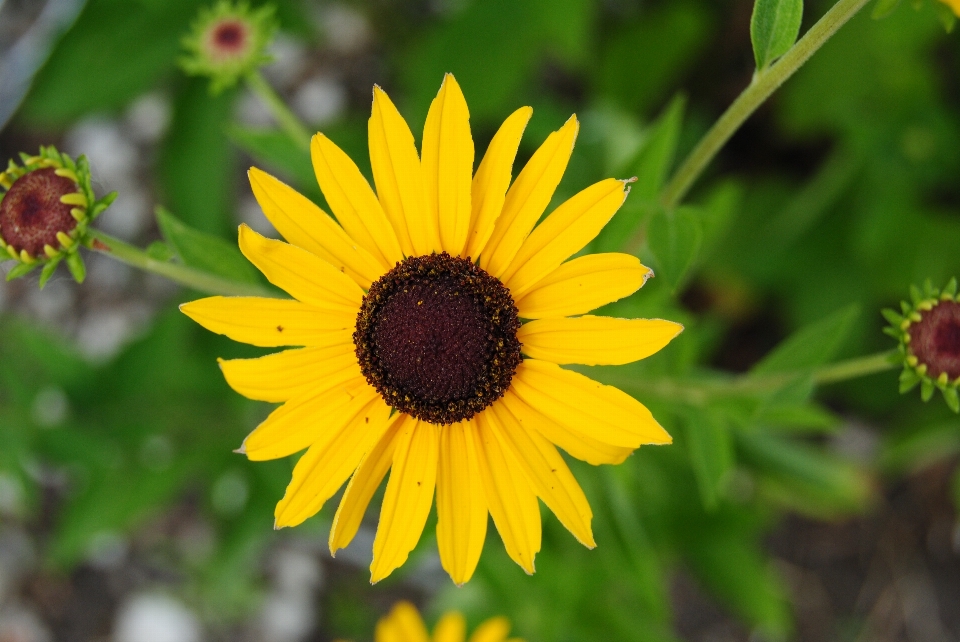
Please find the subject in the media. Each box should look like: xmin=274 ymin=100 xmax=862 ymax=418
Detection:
xmin=353 ymin=252 xmax=521 ymax=424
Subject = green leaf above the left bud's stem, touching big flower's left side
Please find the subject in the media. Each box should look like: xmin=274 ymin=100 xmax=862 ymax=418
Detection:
xmin=157 ymin=207 xmax=259 ymax=283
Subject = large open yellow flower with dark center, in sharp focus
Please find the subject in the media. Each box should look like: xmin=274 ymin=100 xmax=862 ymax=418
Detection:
xmin=181 ymin=75 xmax=682 ymax=584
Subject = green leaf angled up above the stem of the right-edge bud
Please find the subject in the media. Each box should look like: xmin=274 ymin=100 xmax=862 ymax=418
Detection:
xmin=750 ymin=304 xmax=859 ymax=375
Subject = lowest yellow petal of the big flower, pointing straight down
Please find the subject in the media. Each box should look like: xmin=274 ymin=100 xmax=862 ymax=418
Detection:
xmin=437 ymin=421 xmax=487 ymax=586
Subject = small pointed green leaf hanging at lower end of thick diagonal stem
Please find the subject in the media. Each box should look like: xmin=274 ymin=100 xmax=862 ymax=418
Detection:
xmin=647 ymin=207 xmax=703 ymax=291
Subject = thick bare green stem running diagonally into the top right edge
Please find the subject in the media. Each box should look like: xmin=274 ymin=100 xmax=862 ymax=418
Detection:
xmin=660 ymin=0 xmax=870 ymax=209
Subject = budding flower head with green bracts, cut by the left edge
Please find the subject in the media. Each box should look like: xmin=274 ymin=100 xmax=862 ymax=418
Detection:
xmin=0 ymin=147 xmax=116 ymax=287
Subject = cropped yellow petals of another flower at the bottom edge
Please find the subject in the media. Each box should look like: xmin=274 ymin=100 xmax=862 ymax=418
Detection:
xmin=344 ymin=602 xmax=523 ymax=642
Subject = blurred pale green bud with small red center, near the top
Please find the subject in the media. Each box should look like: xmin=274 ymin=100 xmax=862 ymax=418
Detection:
xmin=180 ymin=0 xmax=277 ymax=93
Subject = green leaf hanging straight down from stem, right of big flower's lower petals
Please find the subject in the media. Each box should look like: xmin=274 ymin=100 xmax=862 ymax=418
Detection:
xmin=685 ymin=411 xmax=733 ymax=511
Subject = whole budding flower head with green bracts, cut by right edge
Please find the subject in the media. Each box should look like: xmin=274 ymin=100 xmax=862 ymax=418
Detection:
xmin=883 ymin=279 xmax=960 ymax=412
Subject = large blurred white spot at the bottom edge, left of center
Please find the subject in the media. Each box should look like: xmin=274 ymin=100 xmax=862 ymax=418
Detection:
xmin=113 ymin=594 xmax=202 ymax=642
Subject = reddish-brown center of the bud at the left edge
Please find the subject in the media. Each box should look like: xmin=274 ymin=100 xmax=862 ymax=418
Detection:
xmin=0 ymin=167 xmax=77 ymax=256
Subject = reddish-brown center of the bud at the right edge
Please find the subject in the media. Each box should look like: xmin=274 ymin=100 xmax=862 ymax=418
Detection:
xmin=910 ymin=301 xmax=960 ymax=381
